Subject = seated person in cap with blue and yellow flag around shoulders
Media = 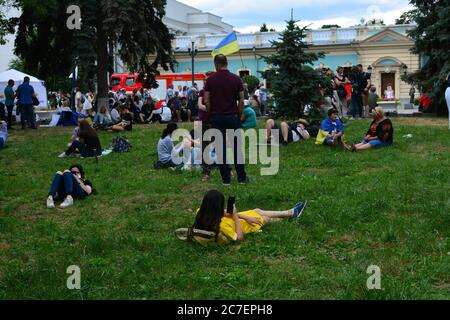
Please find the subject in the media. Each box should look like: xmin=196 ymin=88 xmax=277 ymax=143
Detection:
xmin=316 ymin=109 xmax=345 ymax=147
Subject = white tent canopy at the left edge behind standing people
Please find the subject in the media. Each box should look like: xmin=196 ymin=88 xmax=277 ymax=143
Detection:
xmin=0 ymin=69 xmax=47 ymax=108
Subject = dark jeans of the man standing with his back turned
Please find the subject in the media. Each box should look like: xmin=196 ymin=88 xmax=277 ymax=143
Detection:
xmin=210 ymin=115 xmax=247 ymax=184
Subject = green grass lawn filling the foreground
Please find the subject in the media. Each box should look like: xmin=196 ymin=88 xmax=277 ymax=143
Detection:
xmin=0 ymin=118 xmax=450 ymax=299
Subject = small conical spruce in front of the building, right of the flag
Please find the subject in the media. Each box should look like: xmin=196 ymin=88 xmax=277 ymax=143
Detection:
xmin=263 ymin=20 xmax=324 ymax=117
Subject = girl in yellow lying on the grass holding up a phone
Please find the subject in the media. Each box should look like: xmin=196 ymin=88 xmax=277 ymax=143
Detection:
xmin=181 ymin=190 xmax=307 ymax=245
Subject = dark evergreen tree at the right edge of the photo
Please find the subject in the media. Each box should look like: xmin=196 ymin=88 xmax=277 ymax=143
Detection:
xmin=404 ymin=0 xmax=450 ymax=115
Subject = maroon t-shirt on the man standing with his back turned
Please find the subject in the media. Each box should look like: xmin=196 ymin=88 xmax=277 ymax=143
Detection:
xmin=205 ymin=70 xmax=244 ymax=115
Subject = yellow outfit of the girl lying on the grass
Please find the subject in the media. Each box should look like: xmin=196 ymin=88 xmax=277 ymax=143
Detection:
xmin=194 ymin=210 xmax=265 ymax=245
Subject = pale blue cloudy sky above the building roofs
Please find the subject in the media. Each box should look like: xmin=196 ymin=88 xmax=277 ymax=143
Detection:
xmin=179 ymin=0 xmax=411 ymax=32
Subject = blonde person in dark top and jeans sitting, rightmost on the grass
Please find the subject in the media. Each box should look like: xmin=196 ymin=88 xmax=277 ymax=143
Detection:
xmin=347 ymin=107 xmax=394 ymax=152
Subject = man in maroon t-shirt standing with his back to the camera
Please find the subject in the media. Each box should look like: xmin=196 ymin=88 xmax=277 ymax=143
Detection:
xmin=204 ymin=54 xmax=248 ymax=186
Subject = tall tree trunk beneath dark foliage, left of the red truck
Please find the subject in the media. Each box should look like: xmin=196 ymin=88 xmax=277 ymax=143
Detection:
xmin=97 ymin=19 xmax=109 ymax=110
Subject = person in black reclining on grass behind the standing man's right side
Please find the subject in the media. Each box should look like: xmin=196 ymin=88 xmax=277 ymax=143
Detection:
xmin=266 ymin=119 xmax=317 ymax=145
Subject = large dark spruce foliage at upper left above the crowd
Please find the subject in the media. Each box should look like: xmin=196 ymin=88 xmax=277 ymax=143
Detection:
xmin=7 ymin=0 xmax=174 ymax=103
